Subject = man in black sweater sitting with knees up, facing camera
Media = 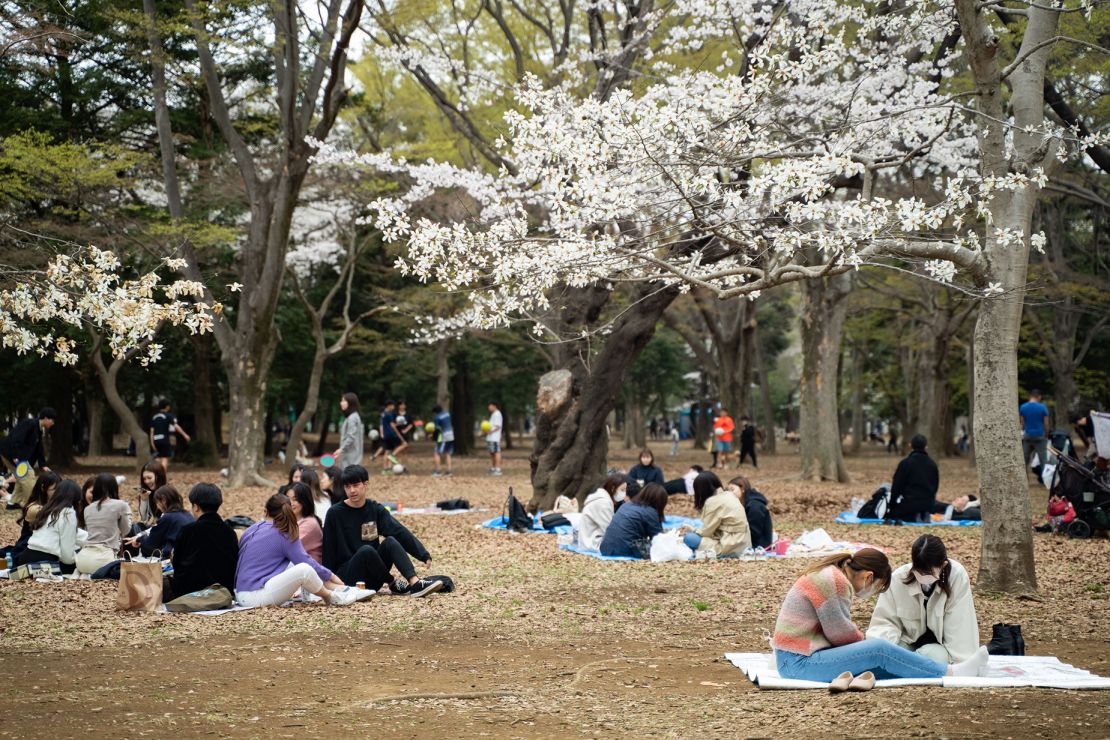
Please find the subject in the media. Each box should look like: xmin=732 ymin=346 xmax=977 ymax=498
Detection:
xmin=324 ymin=465 xmax=443 ymax=596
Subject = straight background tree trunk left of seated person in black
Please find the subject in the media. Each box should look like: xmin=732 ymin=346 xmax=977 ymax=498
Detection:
xmin=799 ymin=273 xmax=851 ymax=483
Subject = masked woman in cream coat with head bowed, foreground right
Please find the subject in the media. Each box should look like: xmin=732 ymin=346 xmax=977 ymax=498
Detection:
xmin=867 ymin=535 xmax=979 ymax=663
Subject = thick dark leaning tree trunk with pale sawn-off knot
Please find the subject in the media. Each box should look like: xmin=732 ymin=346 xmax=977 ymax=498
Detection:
xmin=528 ymin=285 xmax=678 ymax=510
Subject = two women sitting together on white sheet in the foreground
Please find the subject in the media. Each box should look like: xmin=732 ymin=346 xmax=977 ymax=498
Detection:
xmin=771 ymin=535 xmax=988 ymax=691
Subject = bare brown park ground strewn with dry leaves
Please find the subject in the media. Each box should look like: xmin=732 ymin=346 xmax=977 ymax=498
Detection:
xmin=0 ymin=443 xmax=1110 ymax=738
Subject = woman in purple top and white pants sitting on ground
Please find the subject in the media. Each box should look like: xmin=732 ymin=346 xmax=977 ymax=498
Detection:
xmin=235 ymin=494 xmax=372 ymax=607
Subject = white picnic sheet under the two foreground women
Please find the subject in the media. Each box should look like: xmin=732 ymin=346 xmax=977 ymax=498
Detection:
xmin=725 ymin=652 xmax=1110 ymax=690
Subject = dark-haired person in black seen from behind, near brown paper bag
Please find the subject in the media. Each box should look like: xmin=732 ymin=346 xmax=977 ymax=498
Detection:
xmin=162 ymin=483 xmax=239 ymax=601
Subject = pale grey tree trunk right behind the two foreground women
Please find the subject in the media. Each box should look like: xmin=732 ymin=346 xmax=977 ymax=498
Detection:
xmin=956 ymin=0 xmax=1058 ymax=592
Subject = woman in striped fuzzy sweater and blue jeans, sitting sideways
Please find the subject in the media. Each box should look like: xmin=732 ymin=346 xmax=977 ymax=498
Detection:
xmin=771 ymin=547 xmax=987 ymax=689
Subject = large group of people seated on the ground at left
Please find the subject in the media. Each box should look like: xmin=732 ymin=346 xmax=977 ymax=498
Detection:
xmin=3 ymin=462 xmax=445 ymax=607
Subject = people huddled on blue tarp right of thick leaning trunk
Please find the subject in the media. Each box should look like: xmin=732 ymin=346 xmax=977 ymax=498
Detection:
xmin=577 ymin=467 xmax=774 ymax=558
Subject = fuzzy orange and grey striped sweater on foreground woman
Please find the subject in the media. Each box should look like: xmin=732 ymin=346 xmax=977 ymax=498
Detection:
xmin=771 ymin=566 xmax=864 ymax=656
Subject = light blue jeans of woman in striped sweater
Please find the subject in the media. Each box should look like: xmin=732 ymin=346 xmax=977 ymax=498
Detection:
xmin=775 ymin=639 xmax=948 ymax=681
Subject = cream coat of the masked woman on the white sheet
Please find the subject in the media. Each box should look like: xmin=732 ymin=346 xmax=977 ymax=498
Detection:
xmin=867 ymin=558 xmax=979 ymax=663
